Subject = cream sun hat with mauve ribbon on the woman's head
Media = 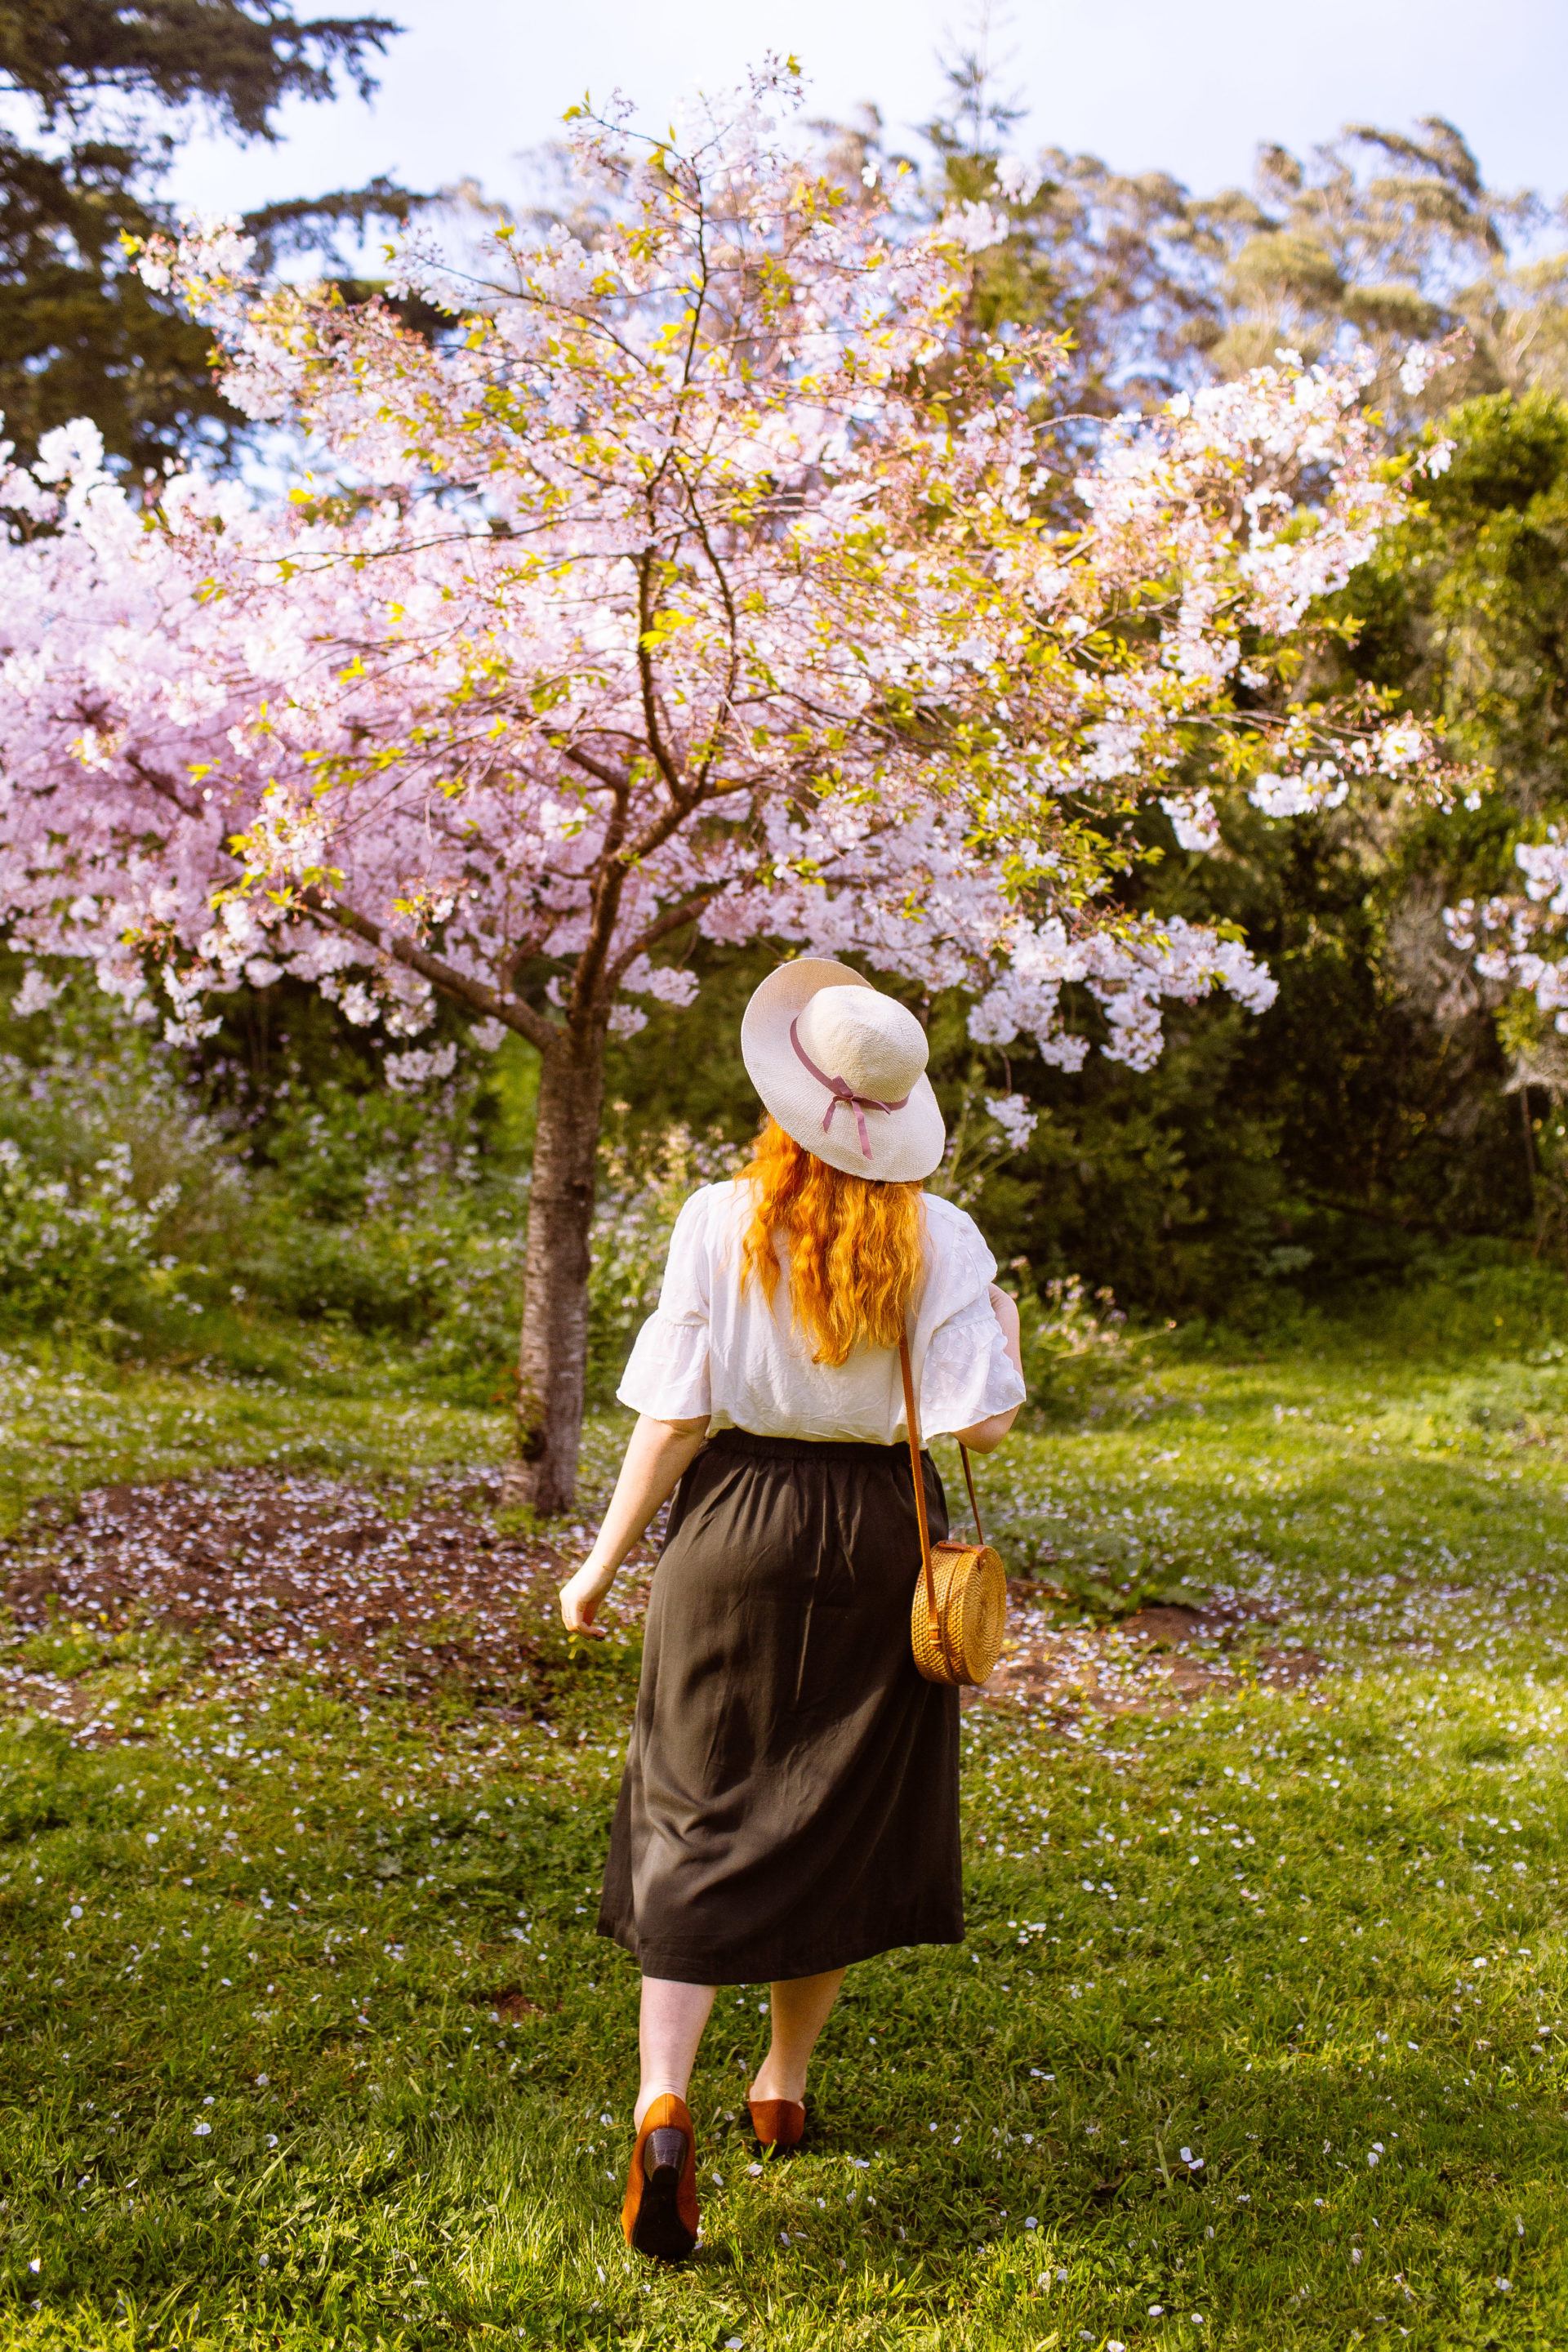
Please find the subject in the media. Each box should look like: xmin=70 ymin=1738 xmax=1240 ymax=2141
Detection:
xmin=741 ymin=955 xmax=947 ymax=1183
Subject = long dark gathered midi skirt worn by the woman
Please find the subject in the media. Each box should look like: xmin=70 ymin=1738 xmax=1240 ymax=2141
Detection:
xmin=599 ymin=1430 xmax=964 ymax=1985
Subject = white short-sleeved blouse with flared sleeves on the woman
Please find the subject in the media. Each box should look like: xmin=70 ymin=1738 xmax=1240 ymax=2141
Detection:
xmin=616 ymin=1183 xmax=1025 ymax=1444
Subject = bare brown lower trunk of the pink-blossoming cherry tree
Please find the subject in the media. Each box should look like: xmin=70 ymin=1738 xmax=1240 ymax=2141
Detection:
xmin=503 ymin=1028 xmax=604 ymax=1515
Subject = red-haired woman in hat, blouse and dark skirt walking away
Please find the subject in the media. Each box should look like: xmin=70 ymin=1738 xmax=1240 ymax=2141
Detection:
xmin=562 ymin=957 xmax=1025 ymax=2261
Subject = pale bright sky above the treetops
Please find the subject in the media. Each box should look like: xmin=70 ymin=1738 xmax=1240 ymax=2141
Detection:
xmin=174 ymin=0 xmax=1568 ymax=212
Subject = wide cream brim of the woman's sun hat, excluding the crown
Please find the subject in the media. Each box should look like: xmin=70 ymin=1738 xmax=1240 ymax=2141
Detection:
xmin=741 ymin=955 xmax=947 ymax=1183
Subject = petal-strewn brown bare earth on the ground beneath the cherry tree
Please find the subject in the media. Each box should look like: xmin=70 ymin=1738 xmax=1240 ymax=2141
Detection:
xmin=0 ymin=1470 xmax=1324 ymax=1735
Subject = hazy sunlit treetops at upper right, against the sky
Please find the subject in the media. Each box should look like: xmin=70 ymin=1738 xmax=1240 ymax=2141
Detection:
xmin=821 ymin=47 xmax=1568 ymax=425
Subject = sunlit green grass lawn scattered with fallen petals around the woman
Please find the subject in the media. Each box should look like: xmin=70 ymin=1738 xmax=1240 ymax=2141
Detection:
xmin=0 ymin=1301 xmax=1568 ymax=2352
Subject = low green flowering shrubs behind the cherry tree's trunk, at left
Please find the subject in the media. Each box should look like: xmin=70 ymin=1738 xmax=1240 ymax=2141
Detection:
xmin=0 ymin=967 xmax=736 ymax=1401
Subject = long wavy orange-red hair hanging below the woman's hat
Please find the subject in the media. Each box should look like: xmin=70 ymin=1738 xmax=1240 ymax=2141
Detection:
xmin=741 ymin=1117 xmax=924 ymax=1364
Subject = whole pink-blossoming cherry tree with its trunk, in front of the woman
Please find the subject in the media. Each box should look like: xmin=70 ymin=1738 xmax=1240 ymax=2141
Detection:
xmin=0 ymin=73 xmax=1434 ymax=1510
